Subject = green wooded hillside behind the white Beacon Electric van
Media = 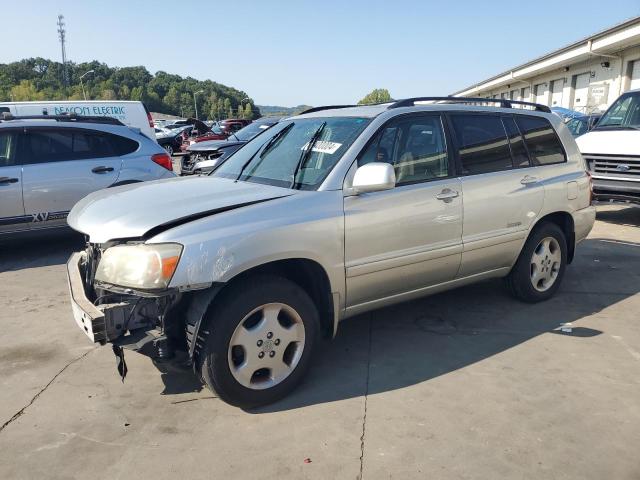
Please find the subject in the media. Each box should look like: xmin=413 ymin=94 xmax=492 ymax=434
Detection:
xmin=0 ymin=58 xmax=260 ymax=120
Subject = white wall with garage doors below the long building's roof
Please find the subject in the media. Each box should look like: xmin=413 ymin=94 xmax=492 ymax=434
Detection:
xmin=474 ymin=45 xmax=640 ymax=113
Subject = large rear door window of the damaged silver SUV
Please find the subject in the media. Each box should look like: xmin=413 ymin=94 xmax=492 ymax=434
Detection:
xmin=451 ymin=115 xmax=512 ymax=175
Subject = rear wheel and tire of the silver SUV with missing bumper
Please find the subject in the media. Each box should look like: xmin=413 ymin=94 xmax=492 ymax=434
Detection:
xmin=505 ymin=222 xmax=567 ymax=303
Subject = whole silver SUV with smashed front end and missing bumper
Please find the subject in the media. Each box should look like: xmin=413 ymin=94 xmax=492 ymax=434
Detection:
xmin=68 ymin=98 xmax=595 ymax=407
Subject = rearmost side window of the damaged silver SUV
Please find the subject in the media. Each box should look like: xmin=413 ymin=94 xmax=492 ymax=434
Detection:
xmin=516 ymin=115 xmax=567 ymax=165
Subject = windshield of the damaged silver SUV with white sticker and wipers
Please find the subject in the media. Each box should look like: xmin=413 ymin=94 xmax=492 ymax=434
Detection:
xmin=213 ymin=117 xmax=369 ymax=190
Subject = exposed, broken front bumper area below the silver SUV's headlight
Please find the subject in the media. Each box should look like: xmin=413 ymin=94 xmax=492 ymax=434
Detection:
xmin=67 ymin=244 xmax=185 ymax=378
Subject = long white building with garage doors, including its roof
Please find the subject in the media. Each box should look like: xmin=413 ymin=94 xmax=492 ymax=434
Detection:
xmin=452 ymin=17 xmax=640 ymax=113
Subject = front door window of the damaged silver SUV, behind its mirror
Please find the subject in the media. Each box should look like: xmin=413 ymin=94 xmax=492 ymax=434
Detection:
xmin=358 ymin=115 xmax=449 ymax=185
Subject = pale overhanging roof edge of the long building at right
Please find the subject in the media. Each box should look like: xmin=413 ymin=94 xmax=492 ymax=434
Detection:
xmin=452 ymin=17 xmax=640 ymax=96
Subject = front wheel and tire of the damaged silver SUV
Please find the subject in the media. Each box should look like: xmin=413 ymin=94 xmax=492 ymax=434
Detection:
xmin=196 ymin=275 xmax=319 ymax=408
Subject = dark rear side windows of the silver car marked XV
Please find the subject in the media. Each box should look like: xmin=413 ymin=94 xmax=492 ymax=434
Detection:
xmin=24 ymin=128 xmax=138 ymax=163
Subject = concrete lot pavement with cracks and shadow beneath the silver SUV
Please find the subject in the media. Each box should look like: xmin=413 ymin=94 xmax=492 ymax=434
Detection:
xmin=0 ymin=207 xmax=640 ymax=480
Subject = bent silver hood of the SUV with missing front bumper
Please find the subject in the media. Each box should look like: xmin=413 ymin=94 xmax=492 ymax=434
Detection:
xmin=67 ymin=176 xmax=294 ymax=243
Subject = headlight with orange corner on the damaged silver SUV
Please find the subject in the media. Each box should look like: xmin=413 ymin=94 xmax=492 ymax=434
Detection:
xmin=95 ymin=243 xmax=182 ymax=290
